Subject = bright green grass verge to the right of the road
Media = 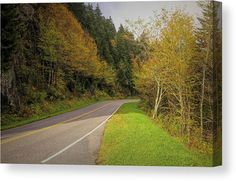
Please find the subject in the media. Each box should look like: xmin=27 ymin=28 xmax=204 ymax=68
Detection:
xmin=97 ymin=103 xmax=212 ymax=166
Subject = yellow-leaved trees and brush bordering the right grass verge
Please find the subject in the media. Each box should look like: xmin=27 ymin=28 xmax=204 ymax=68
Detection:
xmin=129 ymin=1 xmax=222 ymax=160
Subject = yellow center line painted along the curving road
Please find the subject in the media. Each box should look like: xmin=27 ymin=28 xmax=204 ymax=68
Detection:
xmin=1 ymin=103 xmax=111 ymax=145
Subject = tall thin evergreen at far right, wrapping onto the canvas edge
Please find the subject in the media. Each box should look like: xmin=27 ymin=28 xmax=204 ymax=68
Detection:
xmin=196 ymin=1 xmax=222 ymax=139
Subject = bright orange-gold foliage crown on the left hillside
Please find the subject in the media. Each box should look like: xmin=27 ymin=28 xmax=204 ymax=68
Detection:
xmin=37 ymin=4 xmax=114 ymax=82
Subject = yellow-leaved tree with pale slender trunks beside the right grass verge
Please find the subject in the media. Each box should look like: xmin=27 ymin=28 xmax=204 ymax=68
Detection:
xmin=136 ymin=11 xmax=196 ymax=143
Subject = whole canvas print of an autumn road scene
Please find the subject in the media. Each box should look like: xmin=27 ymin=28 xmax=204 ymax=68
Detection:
xmin=1 ymin=1 xmax=222 ymax=167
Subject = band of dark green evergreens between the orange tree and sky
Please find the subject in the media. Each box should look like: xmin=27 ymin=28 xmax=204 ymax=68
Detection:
xmin=68 ymin=3 xmax=136 ymax=95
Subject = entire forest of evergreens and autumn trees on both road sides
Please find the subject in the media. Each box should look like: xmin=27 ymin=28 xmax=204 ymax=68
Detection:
xmin=1 ymin=1 xmax=222 ymax=152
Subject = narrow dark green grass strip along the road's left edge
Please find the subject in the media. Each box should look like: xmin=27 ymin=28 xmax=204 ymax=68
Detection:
xmin=1 ymin=98 xmax=107 ymax=130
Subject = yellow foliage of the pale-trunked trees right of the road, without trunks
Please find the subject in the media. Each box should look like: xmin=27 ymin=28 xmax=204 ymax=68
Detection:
xmin=133 ymin=11 xmax=196 ymax=109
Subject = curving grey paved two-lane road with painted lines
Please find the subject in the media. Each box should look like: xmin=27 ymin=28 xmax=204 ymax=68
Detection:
xmin=1 ymin=99 xmax=136 ymax=165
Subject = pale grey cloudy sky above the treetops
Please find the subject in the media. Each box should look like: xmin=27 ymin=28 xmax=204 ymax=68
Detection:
xmin=93 ymin=1 xmax=201 ymax=30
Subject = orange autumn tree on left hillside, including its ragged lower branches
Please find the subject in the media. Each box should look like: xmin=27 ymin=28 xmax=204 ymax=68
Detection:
xmin=38 ymin=4 xmax=113 ymax=95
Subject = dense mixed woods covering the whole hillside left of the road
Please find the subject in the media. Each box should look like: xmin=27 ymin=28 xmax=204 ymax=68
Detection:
xmin=1 ymin=3 xmax=134 ymax=113
